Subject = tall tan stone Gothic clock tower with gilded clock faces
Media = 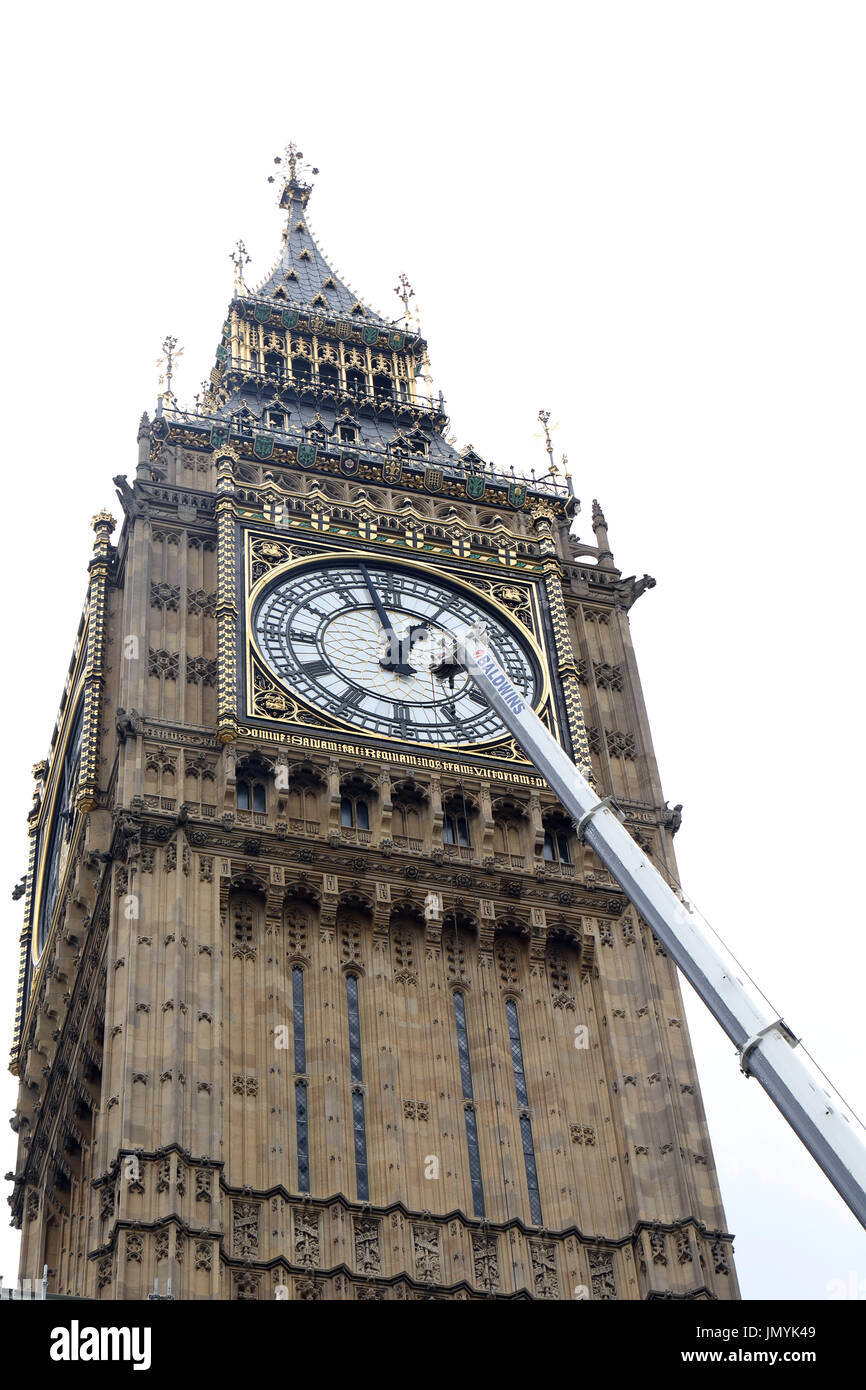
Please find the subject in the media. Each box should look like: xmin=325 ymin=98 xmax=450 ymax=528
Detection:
xmin=11 ymin=147 xmax=738 ymax=1301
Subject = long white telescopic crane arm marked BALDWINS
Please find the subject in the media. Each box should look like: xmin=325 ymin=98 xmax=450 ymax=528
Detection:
xmin=436 ymin=627 xmax=866 ymax=1226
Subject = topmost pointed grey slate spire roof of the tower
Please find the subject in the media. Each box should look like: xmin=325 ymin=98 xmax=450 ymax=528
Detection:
xmin=254 ymin=179 xmax=388 ymax=324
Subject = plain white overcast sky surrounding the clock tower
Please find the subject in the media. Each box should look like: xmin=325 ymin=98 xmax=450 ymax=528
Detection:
xmin=0 ymin=0 xmax=866 ymax=1298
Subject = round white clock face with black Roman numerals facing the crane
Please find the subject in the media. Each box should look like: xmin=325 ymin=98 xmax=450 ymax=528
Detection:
xmin=253 ymin=560 xmax=541 ymax=745
